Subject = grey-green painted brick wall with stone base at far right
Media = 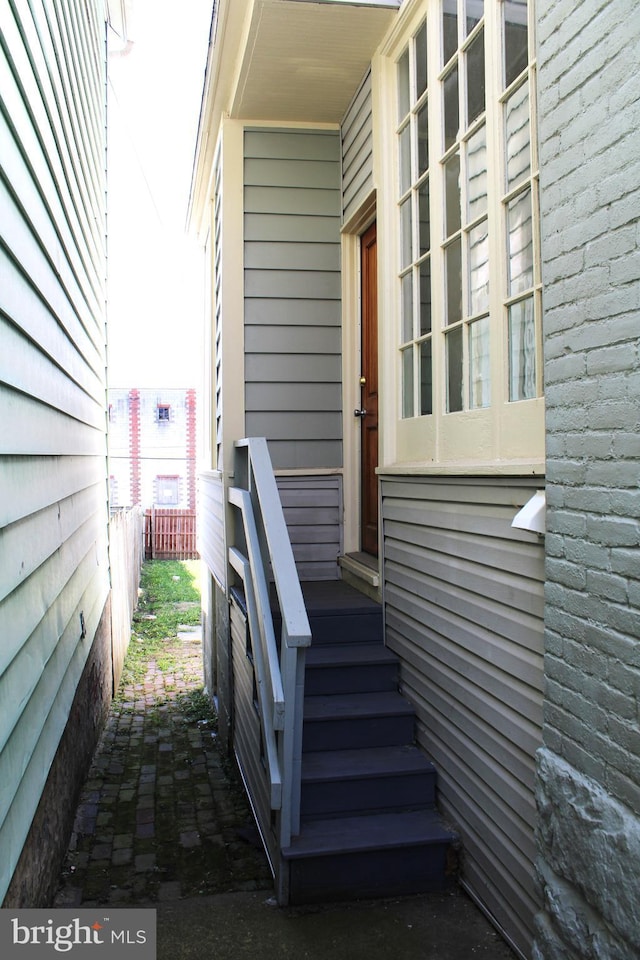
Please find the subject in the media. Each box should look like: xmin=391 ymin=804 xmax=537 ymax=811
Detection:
xmin=534 ymin=0 xmax=640 ymax=960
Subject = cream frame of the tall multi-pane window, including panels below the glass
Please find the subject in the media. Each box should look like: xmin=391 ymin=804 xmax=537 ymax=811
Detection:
xmin=373 ymin=0 xmax=544 ymax=473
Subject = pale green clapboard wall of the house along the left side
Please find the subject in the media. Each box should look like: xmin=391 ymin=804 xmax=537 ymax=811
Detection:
xmin=0 ymin=0 xmax=111 ymax=906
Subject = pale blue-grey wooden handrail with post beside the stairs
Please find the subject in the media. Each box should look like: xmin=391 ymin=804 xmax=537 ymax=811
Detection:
xmin=228 ymin=437 xmax=311 ymax=902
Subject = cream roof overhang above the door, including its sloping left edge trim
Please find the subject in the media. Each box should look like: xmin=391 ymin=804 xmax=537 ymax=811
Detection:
xmin=189 ymin=0 xmax=401 ymax=234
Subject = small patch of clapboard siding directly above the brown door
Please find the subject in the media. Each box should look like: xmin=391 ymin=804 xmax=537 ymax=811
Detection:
xmin=341 ymin=71 xmax=373 ymax=222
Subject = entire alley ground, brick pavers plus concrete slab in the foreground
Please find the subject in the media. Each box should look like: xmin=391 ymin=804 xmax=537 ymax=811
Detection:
xmin=53 ymin=564 xmax=514 ymax=960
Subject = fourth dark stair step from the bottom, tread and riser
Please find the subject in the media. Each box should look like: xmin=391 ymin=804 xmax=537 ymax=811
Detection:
xmin=305 ymin=643 xmax=398 ymax=695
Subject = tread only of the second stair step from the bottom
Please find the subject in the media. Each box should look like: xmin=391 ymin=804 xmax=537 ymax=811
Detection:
xmin=302 ymin=744 xmax=435 ymax=782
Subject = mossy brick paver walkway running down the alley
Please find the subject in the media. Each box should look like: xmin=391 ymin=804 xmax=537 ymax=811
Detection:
xmin=54 ymin=632 xmax=272 ymax=907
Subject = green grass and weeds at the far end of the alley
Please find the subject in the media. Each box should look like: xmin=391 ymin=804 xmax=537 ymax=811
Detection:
xmin=119 ymin=560 xmax=200 ymax=696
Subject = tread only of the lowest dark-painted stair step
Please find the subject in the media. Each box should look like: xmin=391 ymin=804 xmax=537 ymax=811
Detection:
xmin=282 ymin=809 xmax=454 ymax=859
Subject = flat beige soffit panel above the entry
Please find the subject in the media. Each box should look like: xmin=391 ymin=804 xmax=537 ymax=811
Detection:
xmin=231 ymin=0 xmax=397 ymax=123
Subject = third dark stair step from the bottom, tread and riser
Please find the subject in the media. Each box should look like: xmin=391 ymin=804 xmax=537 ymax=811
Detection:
xmin=302 ymin=691 xmax=414 ymax=752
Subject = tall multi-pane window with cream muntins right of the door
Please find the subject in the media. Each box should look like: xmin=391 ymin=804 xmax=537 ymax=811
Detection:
xmin=396 ymin=0 xmax=539 ymax=418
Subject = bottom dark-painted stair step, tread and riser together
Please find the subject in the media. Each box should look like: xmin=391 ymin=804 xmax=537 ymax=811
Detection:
xmin=282 ymin=810 xmax=454 ymax=903
